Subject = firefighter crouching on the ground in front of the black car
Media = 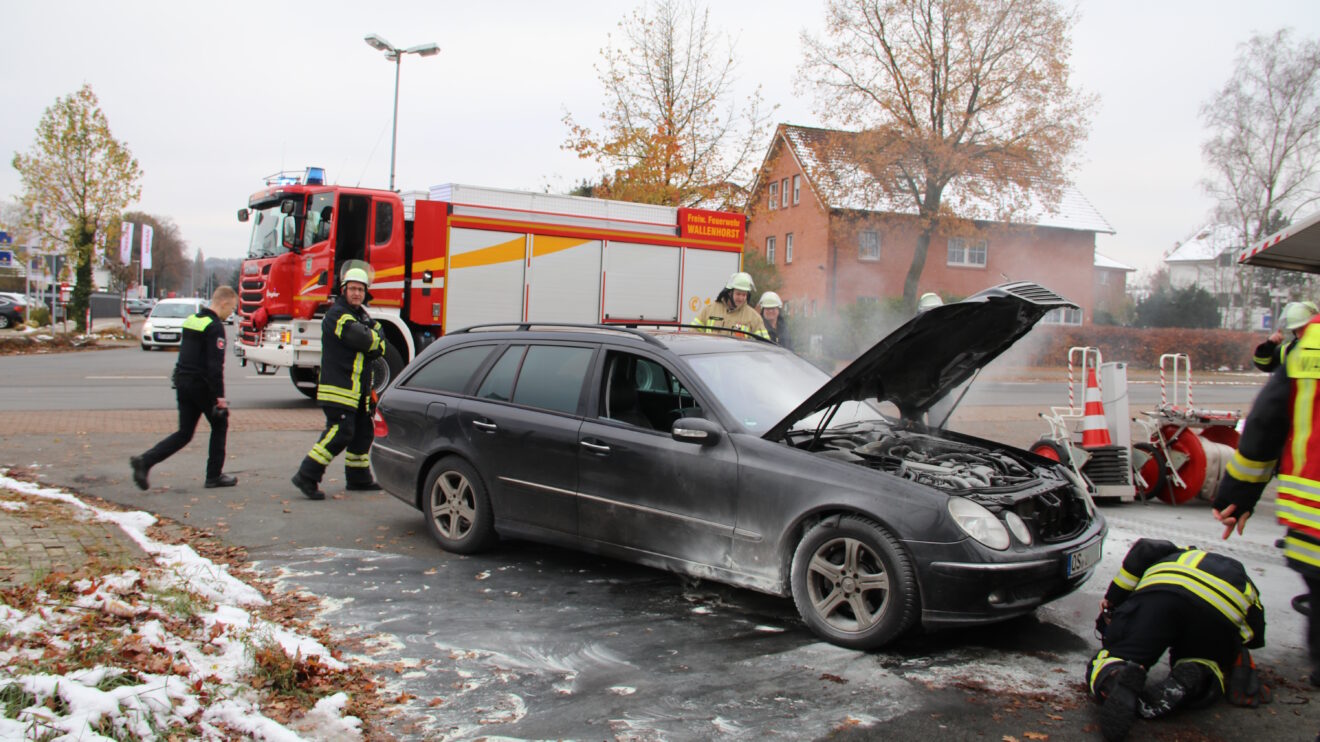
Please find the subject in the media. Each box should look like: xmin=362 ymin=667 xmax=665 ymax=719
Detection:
xmin=1086 ymin=539 xmax=1267 ymax=741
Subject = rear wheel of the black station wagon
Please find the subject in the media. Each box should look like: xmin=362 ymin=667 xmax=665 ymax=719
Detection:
xmin=422 ymin=455 xmax=495 ymax=555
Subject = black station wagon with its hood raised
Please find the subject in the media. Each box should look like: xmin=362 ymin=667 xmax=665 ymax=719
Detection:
xmin=371 ymin=283 xmax=1105 ymax=648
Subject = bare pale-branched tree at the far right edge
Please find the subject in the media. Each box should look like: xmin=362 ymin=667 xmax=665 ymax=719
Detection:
xmin=1201 ymin=29 xmax=1320 ymax=326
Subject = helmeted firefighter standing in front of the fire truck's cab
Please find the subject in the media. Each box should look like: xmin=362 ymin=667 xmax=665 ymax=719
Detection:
xmin=293 ymin=260 xmax=385 ymax=500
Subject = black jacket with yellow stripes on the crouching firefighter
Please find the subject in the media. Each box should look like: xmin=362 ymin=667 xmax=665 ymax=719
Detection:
xmin=1105 ymin=539 xmax=1265 ymax=648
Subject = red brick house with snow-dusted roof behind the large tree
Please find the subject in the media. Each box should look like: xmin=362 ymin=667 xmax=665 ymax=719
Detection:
xmin=746 ymin=124 xmax=1114 ymax=323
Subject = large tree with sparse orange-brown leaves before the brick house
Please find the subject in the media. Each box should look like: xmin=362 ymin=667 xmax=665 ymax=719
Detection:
xmin=801 ymin=0 xmax=1093 ymax=312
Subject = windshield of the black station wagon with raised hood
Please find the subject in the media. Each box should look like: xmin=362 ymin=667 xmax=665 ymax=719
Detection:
xmin=688 ymin=350 xmax=883 ymax=433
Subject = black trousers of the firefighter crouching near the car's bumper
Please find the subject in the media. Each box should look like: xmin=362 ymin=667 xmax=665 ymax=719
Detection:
xmin=1086 ymin=590 xmax=1242 ymax=694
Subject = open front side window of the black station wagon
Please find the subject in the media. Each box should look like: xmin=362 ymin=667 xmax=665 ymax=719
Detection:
xmin=597 ymin=351 xmax=702 ymax=430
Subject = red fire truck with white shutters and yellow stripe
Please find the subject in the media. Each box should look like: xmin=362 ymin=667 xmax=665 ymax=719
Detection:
xmin=235 ymin=168 xmax=746 ymax=396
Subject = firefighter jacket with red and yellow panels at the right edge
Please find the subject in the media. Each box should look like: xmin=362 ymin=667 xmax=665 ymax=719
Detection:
xmin=1214 ymin=318 xmax=1320 ymax=578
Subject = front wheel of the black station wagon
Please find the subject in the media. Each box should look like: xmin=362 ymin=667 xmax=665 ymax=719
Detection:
xmin=791 ymin=515 xmax=917 ymax=650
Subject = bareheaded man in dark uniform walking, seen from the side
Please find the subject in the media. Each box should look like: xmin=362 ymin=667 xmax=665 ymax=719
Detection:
xmin=128 ymin=287 xmax=239 ymax=490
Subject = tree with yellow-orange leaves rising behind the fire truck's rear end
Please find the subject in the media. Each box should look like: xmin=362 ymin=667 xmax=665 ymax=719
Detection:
xmin=564 ymin=0 xmax=768 ymax=206
